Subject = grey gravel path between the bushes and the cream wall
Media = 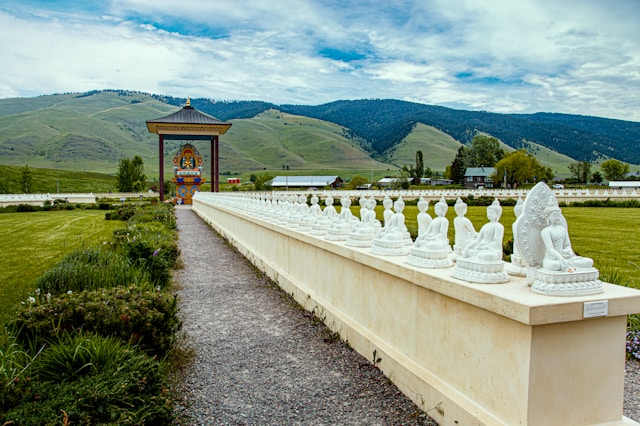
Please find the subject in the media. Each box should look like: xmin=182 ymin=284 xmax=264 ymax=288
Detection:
xmin=174 ymin=208 xmax=640 ymax=425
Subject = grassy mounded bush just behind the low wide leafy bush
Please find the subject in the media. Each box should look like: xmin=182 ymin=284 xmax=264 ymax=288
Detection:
xmin=36 ymin=246 xmax=154 ymax=295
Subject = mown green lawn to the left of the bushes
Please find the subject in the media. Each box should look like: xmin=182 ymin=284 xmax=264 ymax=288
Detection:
xmin=0 ymin=209 xmax=123 ymax=324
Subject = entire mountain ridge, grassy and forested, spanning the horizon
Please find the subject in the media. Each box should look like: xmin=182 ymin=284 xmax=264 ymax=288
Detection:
xmin=0 ymin=90 xmax=640 ymax=179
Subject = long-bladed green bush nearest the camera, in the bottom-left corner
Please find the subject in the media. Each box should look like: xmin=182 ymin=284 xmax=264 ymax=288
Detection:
xmin=1 ymin=336 xmax=175 ymax=425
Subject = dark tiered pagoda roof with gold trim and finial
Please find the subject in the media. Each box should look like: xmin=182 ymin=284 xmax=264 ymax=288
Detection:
xmin=147 ymin=100 xmax=231 ymax=139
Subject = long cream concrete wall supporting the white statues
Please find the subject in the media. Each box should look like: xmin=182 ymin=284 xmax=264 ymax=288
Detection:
xmin=193 ymin=195 xmax=640 ymax=425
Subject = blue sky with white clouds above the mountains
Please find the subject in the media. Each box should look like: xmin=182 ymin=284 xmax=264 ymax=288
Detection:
xmin=0 ymin=0 xmax=640 ymax=121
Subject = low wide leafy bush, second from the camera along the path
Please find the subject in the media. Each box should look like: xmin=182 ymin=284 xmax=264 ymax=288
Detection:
xmin=9 ymin=287 xmax=182 ymax=357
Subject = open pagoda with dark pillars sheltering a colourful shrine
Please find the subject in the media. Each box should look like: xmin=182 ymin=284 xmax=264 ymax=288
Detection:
xmin=147 ymin=99 xmax=231 ymax=202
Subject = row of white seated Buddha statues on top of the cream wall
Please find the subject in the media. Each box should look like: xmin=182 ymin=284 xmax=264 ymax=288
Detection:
xmin=224 ymin=182 xmax=603 ymax=296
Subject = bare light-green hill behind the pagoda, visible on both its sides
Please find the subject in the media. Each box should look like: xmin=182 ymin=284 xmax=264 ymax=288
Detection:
xmin=0 ymin=91 xmax=398 ymax=178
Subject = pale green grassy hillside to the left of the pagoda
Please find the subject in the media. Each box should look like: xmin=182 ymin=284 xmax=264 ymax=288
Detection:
xmin=0 ymin=92 xmax=176 ymax=173
